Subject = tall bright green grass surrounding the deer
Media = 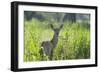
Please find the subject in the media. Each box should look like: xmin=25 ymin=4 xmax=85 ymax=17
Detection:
xmin=24 ymin=18 xmax=90 ymax=62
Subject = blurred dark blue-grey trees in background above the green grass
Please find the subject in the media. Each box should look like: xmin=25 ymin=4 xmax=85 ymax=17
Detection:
xmin=24 ymin=11 xmax=90 ymax=27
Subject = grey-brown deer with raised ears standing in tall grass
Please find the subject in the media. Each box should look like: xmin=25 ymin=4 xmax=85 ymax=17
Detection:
xmin=41 ymin=24 xmax=63 ymax=60
